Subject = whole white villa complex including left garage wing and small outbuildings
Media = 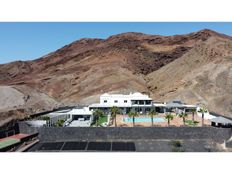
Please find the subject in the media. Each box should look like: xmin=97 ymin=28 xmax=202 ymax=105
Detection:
xmin=26 ymin=92 xmax=227 ymax=127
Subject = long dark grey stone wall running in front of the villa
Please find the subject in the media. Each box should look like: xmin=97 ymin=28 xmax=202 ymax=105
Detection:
xmin=39 ymin=127 xmax=231 ymax=141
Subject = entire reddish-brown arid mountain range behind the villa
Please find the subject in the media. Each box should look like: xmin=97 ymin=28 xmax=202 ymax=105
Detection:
xmin=0 ymin=30 xmax=232 ymax=123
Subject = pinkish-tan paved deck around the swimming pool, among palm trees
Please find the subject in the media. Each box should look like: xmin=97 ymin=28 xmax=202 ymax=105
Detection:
xmin=111 ymin=114 xmax=211 ymax=127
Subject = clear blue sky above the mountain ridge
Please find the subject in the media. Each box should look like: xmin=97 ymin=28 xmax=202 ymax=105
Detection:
xmin=0 ymin=22 xmax=232 ymax=64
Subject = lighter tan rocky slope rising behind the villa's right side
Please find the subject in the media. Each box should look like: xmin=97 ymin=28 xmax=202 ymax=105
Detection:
xmin=147 ymin=35 xmax=232 ymax=116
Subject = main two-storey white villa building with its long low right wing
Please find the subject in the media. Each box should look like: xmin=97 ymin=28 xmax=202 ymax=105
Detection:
xmin=89 ymin=92 xmax=197 ymax=114
